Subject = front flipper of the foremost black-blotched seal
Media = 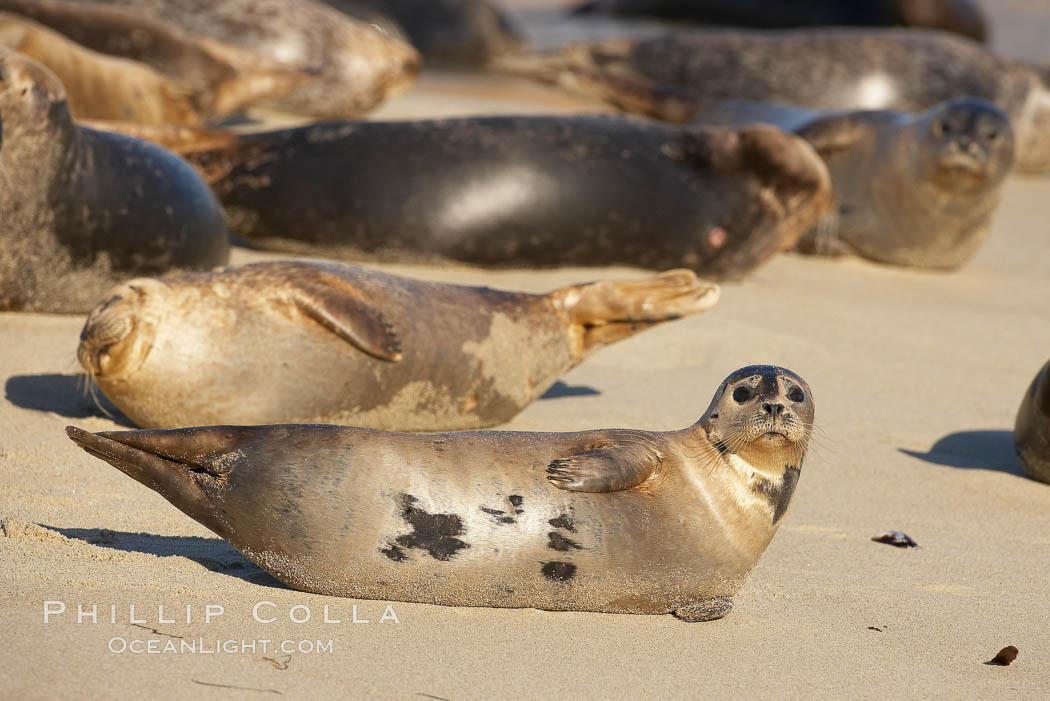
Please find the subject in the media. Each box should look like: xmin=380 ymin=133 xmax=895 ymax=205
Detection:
xmin=547 ymin=439 xmax=663 ymax=492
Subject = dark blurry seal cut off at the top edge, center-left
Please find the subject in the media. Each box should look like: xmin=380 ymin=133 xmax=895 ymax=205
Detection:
xmin=323 ymin=0 xmax=524 ymax=67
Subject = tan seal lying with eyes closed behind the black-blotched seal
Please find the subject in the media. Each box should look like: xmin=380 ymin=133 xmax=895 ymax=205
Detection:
xmin=77 ymin=261 xmax=718 ymax=430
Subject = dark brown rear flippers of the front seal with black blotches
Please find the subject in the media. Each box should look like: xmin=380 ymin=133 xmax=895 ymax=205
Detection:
xmin=66 ymin=426 xmax=239 ymax=535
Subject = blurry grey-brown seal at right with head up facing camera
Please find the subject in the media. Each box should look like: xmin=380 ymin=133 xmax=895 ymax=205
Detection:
xmin=697 ymin=98 xmax=1014 ymax=270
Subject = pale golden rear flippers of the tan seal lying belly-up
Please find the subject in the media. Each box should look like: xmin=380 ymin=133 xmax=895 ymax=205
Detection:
xmin=551 ymin=269 xmax=721 ymax=355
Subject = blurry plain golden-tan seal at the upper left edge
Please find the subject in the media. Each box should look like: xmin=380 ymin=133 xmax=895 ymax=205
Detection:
xmin=0 ymin=12 xmax=202 ymax=124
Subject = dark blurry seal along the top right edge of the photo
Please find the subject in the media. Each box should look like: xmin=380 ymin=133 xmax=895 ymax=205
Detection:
xmin=572 ymin=0 xmax=988 ymax=41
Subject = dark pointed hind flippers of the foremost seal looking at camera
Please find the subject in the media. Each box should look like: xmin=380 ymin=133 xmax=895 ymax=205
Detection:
xmin=66 ymin=426 xmax=225 ymax=535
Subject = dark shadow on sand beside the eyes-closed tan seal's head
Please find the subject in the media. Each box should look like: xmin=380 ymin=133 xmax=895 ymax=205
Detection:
xmin=4 ymin=374 xmax=135 ymax=428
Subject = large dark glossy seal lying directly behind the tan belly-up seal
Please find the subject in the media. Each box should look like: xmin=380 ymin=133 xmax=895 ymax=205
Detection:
xmin=170 ymin=116 xmax=831 ymax=278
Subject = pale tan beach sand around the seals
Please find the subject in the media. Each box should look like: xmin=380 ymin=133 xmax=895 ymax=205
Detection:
xmin=0 ymin=2 xmax=1050 ymax=699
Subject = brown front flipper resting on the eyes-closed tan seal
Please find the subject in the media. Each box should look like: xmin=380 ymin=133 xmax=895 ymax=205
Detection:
xmin=279 ymin=265 xmax=401 ymax=362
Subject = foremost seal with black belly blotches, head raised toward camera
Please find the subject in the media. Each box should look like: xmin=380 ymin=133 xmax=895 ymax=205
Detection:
xmin=66 ymin=366 xmax=814 ymax=620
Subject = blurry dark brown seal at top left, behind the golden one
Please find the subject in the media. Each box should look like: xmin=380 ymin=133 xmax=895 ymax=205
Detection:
xmin=0 ymin=0 xmax=310 ymax=119
